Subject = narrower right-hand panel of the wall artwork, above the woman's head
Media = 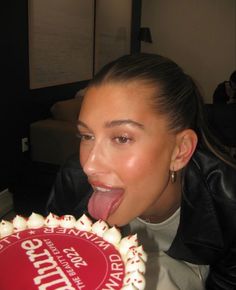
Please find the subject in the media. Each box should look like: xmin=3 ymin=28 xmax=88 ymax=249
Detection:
xmin=95 ymin=0 xmax=132 ymax=72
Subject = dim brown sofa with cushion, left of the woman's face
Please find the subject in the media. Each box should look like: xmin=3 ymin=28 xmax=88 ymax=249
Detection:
xmin=29 ymin=89 xmax=85 ymax=165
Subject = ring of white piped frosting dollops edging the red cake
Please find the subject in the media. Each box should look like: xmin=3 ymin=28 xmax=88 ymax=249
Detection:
xmin=0 ymin=213 xmax=147 ymax=290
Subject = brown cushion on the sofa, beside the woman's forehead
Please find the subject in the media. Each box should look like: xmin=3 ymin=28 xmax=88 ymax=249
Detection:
xmin=50 ymin=97 xmax=82 ymax=123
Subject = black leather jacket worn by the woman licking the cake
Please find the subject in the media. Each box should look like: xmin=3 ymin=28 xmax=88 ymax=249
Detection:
xmin=47 ymin=150 xmax=236 ymax=290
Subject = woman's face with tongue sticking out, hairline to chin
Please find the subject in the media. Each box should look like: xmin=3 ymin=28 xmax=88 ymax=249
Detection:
xmin=78 ymin=82 xmax=178 ymax=226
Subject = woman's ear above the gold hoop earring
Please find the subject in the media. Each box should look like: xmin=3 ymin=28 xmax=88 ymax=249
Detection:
xmin=170 ymin=129 xmax=198 ymax=171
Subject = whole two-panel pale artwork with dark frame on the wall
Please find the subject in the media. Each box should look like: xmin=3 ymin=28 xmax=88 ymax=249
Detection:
xmin=28 ymin=0 xmax=141 ymax=90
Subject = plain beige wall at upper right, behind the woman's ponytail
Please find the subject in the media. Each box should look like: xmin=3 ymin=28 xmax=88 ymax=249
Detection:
xmin=141 ymin=0 xmax=236 ymax=103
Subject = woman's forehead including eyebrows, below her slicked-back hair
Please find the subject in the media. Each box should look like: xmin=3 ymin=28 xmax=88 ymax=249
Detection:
xmin=79 ymin=82 xmax=172 ymax=135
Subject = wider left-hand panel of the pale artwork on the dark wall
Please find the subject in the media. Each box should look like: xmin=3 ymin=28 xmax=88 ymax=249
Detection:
xmin=28 ymin=0 xmax=94 ymax=89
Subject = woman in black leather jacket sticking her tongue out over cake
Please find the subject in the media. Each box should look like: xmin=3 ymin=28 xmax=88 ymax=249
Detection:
xmin=48 ymin=54 xmax=236 ymax=290
